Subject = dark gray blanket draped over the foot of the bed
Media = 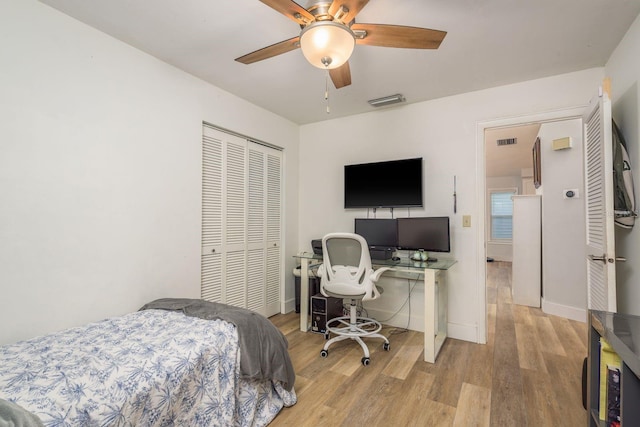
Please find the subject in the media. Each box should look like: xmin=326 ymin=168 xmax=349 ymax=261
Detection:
xmin=140 ymin=298 xmax=296 ymax=391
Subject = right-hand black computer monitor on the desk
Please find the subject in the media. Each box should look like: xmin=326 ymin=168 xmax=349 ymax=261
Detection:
xmin=398 ymin=216 xmax=451 ymax=252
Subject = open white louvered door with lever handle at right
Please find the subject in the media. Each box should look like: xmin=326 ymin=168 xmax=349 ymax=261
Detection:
xmin=583 ymin=91 xmax=617 ymax=312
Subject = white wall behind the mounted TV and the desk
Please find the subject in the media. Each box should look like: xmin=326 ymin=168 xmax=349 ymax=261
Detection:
xmin=299 ymin=68 xmax=603 ymax=341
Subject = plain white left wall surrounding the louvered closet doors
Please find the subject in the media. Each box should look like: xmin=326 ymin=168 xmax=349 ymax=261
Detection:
xmin=0 ymin=0 xmax=298 ymax=343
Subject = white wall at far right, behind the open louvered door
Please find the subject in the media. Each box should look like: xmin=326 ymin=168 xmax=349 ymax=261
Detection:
xmin=605 ymin=13 xmax=640 ymax=315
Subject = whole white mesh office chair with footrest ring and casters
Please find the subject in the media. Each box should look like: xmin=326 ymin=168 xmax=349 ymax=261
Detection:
xmin=318 ymin=233 xmax=390 ymax=366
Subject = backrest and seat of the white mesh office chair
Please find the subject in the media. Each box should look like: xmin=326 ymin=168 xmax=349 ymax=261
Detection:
xmin=320 ymin=233 xmax=380 ymax=300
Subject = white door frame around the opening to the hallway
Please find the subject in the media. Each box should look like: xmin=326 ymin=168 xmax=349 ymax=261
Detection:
xmin=476 ymin=104 xmax=588 ymax=344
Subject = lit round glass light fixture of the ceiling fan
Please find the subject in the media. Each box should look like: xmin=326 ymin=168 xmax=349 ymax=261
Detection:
xmin=300 ymin=21 xmax=356 ymax=70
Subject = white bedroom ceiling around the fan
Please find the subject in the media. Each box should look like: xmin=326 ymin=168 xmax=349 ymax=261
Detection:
xmin=40 ymin=0 xmax=640 ymax=124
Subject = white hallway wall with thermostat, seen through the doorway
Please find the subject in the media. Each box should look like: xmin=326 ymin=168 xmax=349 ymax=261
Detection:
xmin=538 ymin=119 xmax=587 ymax=321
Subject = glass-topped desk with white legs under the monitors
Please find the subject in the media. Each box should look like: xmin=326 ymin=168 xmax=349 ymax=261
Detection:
xmin=295 ymin=252 xmax=456 ymax=363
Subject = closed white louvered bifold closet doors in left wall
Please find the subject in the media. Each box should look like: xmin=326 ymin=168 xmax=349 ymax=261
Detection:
xmin=202 ymin=125 xmax=282 ymax=316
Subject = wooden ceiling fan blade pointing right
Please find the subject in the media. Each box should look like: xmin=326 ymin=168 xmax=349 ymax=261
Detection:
xmin=351 ymin=23 xmax=447 ymax=49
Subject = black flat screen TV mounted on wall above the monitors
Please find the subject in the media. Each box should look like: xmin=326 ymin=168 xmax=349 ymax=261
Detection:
xmin=344 ymin=158 xmax=422 ymax=209
